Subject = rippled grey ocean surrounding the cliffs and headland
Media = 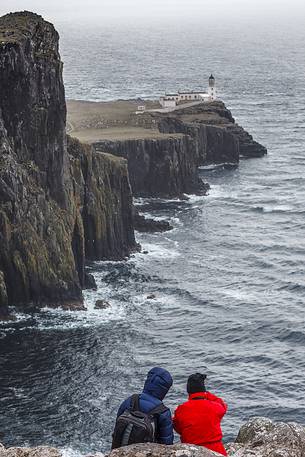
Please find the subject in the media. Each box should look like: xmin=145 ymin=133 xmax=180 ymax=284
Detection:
xmin=0 ymin=22 xmax=305 ymax=455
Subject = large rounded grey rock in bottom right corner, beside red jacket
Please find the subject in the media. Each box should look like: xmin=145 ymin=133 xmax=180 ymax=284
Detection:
xmin=228 ymin=417 xmax=305 ymax=457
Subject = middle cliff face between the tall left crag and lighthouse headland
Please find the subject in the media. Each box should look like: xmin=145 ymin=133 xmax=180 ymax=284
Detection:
xmin=68 ymin=137 xmax=136 ymax=260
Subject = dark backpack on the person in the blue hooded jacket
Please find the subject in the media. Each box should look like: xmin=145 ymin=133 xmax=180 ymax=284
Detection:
xmin=112 ymin=395 xmax=168 ymax=449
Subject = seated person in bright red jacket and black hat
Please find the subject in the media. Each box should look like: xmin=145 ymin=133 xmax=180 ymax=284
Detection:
xmin=173 ymin=373 xmax=228 ymax=455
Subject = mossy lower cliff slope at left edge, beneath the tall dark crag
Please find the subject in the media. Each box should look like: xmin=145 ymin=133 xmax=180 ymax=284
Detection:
xmin=0 ymin=108 xmax=81 ymax=309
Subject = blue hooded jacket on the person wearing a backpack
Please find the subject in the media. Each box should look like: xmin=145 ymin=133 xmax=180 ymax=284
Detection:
xmin=117 ymin=367 xmax=174 ymax=444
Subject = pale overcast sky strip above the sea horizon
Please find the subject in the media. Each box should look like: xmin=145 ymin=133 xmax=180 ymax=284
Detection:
xmin=0 ymin=0 xmax=305 ymax=22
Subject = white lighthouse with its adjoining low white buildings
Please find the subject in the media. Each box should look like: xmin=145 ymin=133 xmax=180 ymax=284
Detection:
xmin=159 ymin=75 xmax=216 ymax=108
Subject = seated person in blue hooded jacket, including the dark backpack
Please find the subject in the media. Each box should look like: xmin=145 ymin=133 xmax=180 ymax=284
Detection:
xmin=112 ymin=367 xmax=174 ymax=449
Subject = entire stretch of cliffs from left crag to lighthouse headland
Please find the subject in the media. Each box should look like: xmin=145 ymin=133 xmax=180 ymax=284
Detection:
xmin=0 ymin=12 xmax=266 ymax=319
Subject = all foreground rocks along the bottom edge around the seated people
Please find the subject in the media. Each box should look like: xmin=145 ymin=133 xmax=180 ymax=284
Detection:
xmin=0 ymin=417 xmax=305 ymax=457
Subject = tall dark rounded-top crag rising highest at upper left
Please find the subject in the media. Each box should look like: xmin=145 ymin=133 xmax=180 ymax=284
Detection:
xmin=0 ymin=12 xmax=68 ymax=206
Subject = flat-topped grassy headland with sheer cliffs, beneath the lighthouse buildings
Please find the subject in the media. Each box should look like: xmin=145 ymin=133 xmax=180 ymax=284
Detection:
xmin=68 ymin=100 xmax=267 ymax=198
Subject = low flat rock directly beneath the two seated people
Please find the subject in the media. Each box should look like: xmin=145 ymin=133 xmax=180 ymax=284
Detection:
xmin=109 ymin=443 xmax=215 ymax=457
